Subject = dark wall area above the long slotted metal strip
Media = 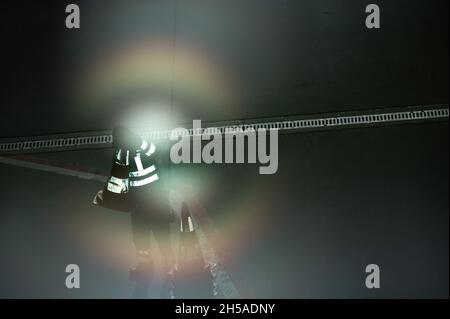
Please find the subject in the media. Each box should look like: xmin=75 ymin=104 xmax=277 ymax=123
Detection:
xmin=0 ymin=0 xmax=448 ymax=136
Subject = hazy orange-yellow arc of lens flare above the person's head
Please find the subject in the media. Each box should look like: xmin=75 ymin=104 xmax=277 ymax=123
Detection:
xmin=76 ymin=42 xmax=241 ymax=120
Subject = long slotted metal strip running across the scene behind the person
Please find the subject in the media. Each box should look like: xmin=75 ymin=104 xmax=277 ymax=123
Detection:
xmin=0 ymin=104 xmax=449 ymax=155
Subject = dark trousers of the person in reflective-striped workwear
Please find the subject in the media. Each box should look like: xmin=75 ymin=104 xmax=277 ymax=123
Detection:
xmin=130 ymin=181 xmax=174 ymax=262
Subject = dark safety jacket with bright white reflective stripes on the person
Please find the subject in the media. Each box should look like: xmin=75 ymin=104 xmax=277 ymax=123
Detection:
xmin=93 ymin=134 xmax=159 ymax=212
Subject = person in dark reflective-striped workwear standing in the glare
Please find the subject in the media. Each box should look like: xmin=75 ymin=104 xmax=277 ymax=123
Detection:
xmin=94 ymin=126 xmax=175 ymax=275
